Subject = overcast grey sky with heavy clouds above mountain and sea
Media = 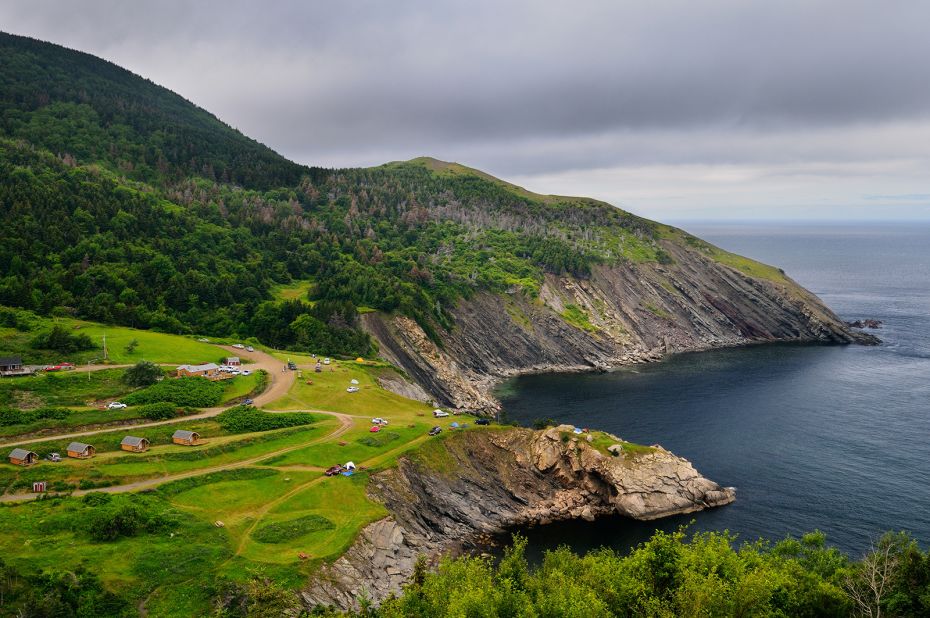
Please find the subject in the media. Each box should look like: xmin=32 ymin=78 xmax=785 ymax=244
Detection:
xmin=0 ymin=0 xmax=930 ymax=221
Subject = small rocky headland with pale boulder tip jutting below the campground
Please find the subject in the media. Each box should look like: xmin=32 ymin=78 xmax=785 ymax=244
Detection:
xmin=303 ymin=426 xmax=735 ymax=608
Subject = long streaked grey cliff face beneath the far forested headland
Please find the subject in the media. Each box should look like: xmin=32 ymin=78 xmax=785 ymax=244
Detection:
xmin=364 ymin=236 xmax=874 ymax=412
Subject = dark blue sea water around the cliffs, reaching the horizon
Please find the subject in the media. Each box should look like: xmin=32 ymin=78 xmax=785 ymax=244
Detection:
xmin=499 ymin=224 xmax=930 ymax=555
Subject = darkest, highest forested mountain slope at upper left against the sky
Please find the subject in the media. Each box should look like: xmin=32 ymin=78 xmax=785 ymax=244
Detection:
xmin=0 ymin=32 xmax=308 ymax=189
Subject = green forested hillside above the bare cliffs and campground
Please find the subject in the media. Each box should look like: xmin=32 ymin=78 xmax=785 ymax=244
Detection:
xmin=0 ymin=34 xmax=669 ymax=353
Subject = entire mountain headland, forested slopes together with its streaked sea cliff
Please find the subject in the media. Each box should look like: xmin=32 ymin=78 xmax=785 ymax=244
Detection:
xmin=0 ymin=35 xmax=861 ymax=409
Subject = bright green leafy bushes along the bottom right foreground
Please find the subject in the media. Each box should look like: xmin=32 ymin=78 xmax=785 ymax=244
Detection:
xmin=376 ymin=532 xmax=930 ymax=618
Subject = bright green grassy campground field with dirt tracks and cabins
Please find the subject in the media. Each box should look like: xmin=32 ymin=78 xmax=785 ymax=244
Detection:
xmin=0 ymin=321 xmax=492 ymax=616
